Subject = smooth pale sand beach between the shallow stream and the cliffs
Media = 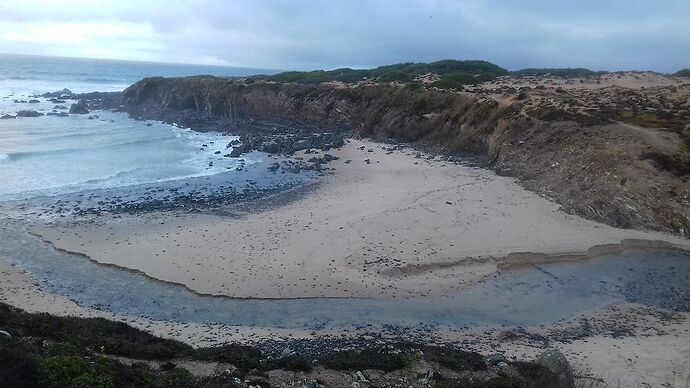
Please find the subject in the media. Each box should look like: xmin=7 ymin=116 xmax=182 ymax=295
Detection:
xmin=33 ymin=140 xmax=684 ymax=298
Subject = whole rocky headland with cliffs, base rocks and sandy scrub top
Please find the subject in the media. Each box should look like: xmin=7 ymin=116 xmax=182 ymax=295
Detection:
xmin=71 ymin=68 xmax=690 ymax=237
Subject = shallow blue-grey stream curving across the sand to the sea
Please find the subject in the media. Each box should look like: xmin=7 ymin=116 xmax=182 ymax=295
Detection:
xmin=0 ymin=221 xmax=690 ymax=329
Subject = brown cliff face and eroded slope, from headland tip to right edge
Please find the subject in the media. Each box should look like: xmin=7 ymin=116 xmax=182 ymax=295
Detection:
xmin=123 ymin=77 xmax=690 ymax=237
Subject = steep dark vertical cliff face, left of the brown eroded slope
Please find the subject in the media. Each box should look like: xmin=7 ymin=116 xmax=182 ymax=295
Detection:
xmin=123 ymin=77 xmax=511 ymax=157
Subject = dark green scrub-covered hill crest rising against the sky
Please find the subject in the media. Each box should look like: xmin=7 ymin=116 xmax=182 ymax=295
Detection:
xmin=267 ymin=59 xmax=508 ymax=88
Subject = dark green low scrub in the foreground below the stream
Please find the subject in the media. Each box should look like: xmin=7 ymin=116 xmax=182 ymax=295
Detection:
xmin=0 ymin=303 xmax=556 ymax=388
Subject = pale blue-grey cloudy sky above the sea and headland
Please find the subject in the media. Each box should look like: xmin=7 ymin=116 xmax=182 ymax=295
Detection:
xmin=0 ymin=0 xmax=690 ymax=72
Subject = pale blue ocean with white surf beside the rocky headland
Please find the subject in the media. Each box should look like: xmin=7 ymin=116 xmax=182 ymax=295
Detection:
xmin=0 ymin=55 xmax=282 ymax=205
